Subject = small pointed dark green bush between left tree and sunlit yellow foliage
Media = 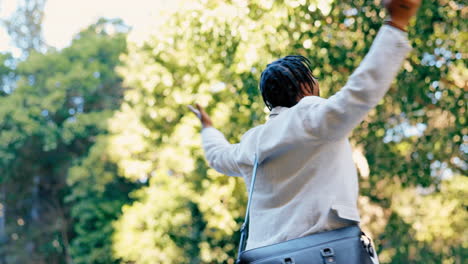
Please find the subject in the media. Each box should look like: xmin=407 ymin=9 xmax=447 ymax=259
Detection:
xmin=65 ymin=136 xmax=136 ymax=264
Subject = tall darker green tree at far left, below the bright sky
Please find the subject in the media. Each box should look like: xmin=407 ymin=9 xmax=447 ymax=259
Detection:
xmin=0 ymin=17 xmax=132 ymax=263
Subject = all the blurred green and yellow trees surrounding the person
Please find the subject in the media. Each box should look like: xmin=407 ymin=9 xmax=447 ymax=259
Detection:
xmin=0 ymin=0 xmax=468 ymax=264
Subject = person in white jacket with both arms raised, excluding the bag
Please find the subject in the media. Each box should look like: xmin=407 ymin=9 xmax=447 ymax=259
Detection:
xmin=190 ymin=0 xmax=421 ymax=256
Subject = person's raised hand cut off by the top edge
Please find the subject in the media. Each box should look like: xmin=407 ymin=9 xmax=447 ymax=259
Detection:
xmin=383 ymin=0 xmax=422 ymax=31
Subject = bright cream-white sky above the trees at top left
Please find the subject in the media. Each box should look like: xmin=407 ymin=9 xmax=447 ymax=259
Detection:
xmin=0 ymin=0 xmax=177 ymax=53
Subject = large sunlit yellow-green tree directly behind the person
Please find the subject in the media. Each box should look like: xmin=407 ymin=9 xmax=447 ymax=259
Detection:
xmin=109 ymin=0 xmax=467 ymax=263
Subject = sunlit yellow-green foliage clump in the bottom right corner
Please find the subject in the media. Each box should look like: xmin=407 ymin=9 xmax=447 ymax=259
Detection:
xmin=392 ymin=176 xmax=468 ymax=263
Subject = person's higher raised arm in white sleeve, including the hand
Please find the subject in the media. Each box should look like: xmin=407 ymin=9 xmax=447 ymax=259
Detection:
xmin=303 ymin=0 xmax=421 ymax=140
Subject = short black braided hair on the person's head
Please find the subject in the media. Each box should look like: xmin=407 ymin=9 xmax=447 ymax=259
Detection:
xmin=260 ymin=55 xmax=316 ymax=110
